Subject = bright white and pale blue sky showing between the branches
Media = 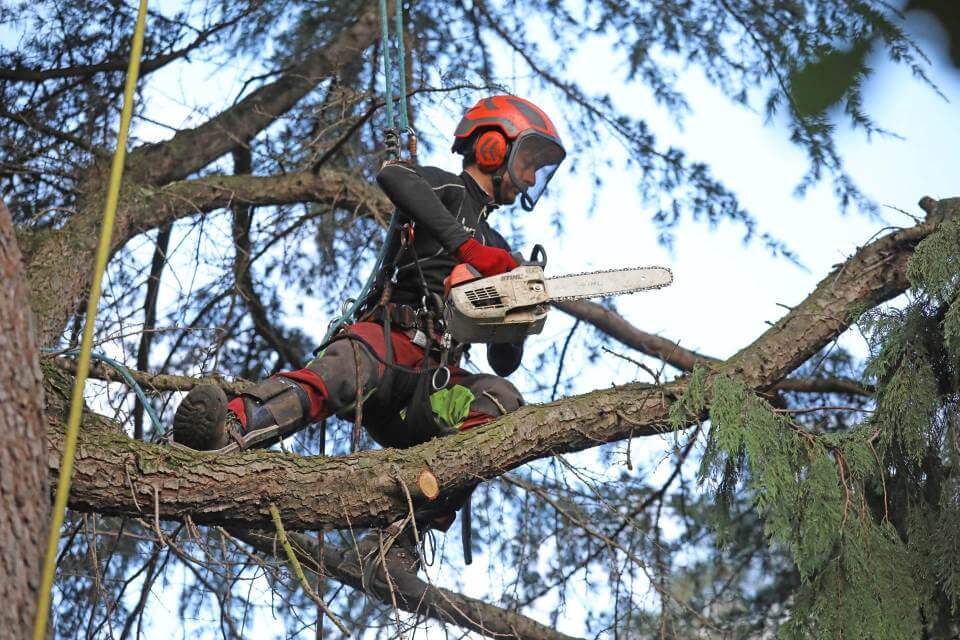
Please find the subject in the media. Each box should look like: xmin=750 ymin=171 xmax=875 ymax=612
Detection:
xmin=26 ymin=5 xmax=960 ymax=636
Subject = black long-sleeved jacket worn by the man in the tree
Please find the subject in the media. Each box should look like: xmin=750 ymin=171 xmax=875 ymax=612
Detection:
xmin=377 ymin=163 xmax=523 ymax=375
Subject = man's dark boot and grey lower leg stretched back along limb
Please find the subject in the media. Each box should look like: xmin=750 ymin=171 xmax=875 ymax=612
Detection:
xmin=173 ymin=376 xmax=310 ymax=453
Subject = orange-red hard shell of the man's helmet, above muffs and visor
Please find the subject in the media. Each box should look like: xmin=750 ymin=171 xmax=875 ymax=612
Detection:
xmin=451 ymin=95 xmax=563 ymax=153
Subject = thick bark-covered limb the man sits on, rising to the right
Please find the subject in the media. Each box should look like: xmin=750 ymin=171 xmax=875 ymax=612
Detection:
xmin=49 ymin=199 xmax=960 ymax=530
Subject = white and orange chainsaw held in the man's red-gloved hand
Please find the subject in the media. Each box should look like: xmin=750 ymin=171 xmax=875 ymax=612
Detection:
xmin=444 ymin=244 xmax=673 ymax=343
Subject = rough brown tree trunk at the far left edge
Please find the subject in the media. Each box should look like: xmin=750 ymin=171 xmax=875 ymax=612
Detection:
xmin=0 ymin=201 xmax=50 ymax=638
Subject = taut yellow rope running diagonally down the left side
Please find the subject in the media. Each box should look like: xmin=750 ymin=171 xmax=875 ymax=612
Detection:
xmin=33 ymin=0 xmax=147 ymax=640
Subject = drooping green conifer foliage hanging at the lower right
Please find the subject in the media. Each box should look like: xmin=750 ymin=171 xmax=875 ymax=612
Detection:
xmin=673 ymin=219 xmax=960 ymax=640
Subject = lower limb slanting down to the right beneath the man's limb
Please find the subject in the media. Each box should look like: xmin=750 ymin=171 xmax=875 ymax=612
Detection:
xmin=230 ymin=529 xmax=572 ymax=640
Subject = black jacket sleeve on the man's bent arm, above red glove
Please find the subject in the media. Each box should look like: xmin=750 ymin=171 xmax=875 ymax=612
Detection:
xmin=377 ymin=164 xmax=470 ymax=253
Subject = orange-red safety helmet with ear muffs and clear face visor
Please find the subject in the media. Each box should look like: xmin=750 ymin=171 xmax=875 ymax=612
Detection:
xmin=452 ymin=96 xmax=566 ymax=211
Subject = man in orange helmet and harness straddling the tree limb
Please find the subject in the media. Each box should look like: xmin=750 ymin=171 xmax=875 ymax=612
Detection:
xmin=173 ymin=95 xmax=565 ymax=480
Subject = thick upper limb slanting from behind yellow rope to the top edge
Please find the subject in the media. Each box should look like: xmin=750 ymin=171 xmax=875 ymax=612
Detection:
xmin=25 ymin=0 xmax=379 ymax=344
